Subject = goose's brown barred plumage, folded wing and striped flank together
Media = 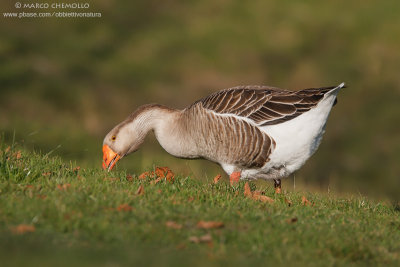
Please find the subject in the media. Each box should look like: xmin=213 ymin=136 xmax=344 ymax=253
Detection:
xmin=182 ymin=86 xmax=335 ymax=168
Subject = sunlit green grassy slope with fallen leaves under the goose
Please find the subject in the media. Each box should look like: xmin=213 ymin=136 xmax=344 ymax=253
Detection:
xmin=0 ymin=147 xmax=400 ymax=266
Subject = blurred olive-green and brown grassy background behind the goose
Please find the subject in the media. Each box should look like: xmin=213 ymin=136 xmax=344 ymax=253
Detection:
xmin=0 ymin=0 xmax=400 ymax=197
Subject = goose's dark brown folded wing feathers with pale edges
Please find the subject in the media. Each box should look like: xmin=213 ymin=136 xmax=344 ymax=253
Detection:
xmin=193 ymin=86 xmax=335 ymax=126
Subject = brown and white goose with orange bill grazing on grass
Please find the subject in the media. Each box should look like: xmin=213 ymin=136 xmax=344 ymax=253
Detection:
xmin=102 ymin=83 xmax=345 ymax=189
